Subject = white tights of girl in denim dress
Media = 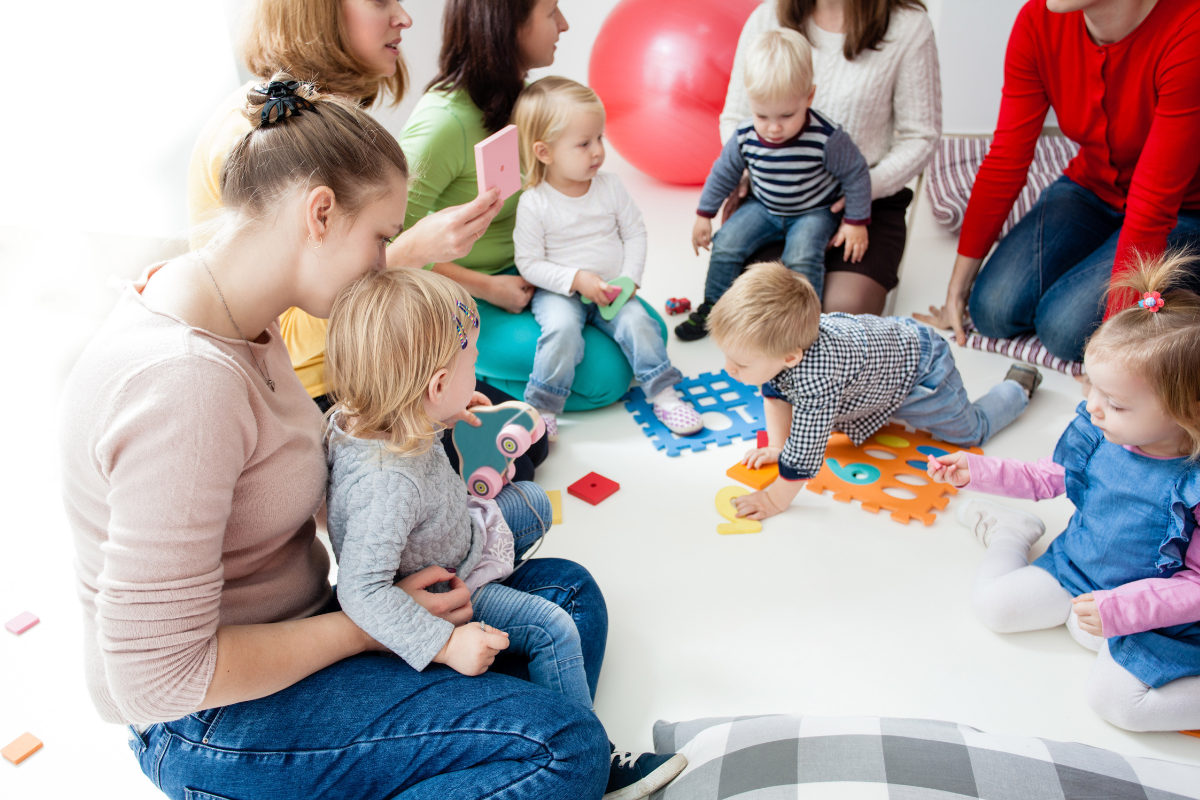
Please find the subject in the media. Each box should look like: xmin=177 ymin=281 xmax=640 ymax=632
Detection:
xmin=971 ymin=520 xmax=1200 ymax=730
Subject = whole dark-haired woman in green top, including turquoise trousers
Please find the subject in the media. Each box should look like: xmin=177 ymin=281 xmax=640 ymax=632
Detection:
xmin=400 ymin=0 xmax=666 ymax=412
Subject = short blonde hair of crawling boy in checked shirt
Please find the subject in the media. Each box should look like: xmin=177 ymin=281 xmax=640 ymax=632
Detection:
xmin=708 ymin=261 xmax=821 ymax=359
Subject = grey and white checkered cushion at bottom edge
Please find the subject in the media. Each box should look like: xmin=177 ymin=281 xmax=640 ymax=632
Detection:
xmin=653 ymin=716 xmax=1200 ymax=800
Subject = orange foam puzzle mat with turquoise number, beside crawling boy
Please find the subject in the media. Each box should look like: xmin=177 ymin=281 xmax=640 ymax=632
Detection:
xmin=808 ymin=425 xmax=983 ymax=525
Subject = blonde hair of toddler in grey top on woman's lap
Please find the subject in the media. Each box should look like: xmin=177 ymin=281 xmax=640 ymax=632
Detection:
xmin=325 ymin=269 xmax=479 ymax=456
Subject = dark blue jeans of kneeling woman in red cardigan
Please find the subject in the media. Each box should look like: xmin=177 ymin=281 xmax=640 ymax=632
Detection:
xmin=968 ymin=176 xmax=1200 ymax=361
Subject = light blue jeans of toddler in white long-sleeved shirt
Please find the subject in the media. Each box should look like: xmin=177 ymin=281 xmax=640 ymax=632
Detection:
xmin=524 ymin=289 xmax=683 ymax=414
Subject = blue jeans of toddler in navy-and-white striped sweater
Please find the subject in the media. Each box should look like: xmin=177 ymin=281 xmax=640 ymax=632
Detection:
xmin=704 ymin=197 xmax=841 ymax=302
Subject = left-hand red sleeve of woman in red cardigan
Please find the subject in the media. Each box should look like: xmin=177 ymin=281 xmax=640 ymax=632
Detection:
xmin=959 ymin=0 xmax=1064 ymax=258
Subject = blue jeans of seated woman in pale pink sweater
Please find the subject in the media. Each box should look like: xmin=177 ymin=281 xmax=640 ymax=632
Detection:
xmin=130 ymin=483 xmax=610 ymax=800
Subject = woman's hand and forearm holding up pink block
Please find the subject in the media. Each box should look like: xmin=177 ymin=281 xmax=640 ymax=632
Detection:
xmin=388 ymin=188 xmax=504 ymax=267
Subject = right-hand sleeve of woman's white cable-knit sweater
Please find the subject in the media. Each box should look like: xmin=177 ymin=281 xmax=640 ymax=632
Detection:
xmin=871 ymin=14 xmax=942 ymax=200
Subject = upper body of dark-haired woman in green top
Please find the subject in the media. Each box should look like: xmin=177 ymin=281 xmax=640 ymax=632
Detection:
xmin=400 ymin=0 xmax=568 ymax=314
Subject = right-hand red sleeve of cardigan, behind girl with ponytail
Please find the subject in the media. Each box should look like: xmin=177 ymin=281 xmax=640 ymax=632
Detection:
xmin=1105 ymin=13 xmax=1200 ymax=317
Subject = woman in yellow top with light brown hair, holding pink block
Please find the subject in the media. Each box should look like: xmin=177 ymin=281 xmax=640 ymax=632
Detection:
xmin=187 ymin=0 xmax=502 ymax=402
